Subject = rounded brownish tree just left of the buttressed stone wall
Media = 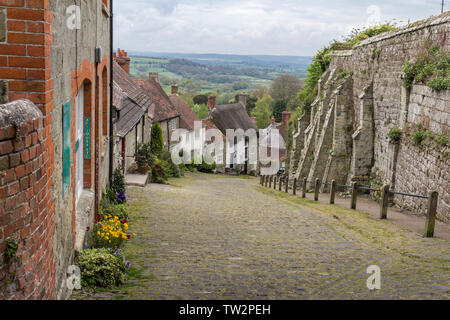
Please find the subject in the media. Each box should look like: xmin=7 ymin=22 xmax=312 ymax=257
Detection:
xmin=270 ymin=74 xmax=302 ymax=110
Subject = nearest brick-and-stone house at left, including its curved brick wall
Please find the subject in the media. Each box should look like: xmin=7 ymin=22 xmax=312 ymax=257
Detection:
xmin=0 ymin=0 xmax=112 ymax=300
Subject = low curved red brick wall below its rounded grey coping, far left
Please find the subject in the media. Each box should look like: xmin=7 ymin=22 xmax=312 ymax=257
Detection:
xmin=0 ymin=118 xmax=55 ymax=300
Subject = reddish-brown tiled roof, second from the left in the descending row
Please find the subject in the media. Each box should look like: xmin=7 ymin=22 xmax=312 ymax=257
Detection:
xmin=136 ymin=79 xmax=180 ymax=122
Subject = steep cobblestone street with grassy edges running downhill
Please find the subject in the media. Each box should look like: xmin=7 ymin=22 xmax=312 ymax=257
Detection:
xmin=74 ymin=174 xmax=450 ymax=299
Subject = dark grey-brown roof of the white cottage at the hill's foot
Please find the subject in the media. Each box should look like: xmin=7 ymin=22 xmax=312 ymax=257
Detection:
xmin=212 ymin=102 xmax=258 ymax=135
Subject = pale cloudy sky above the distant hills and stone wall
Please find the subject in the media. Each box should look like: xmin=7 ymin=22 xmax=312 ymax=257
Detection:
xmin=114 ymin=0 xmax=450 ymax=55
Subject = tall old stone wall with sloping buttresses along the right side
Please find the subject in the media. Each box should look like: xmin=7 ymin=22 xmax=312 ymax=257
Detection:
xmin=290 ymin=12 xmax=450 ymax=222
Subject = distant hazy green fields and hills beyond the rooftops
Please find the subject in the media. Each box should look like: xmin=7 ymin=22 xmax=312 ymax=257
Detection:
xmin=130 ymin=52 xmax=311 ymax=93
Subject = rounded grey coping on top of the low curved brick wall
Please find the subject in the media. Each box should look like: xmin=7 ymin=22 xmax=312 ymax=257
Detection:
xmin=0 ymin=99 xmax=43 ymax=128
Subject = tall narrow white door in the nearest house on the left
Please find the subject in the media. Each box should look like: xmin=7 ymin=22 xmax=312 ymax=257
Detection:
xmin=75 ymin=85 xmax=84 ymax=204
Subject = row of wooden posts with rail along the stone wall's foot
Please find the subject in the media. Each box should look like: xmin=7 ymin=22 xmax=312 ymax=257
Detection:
xmin=260 ymin=175 xmax=438 ymax=238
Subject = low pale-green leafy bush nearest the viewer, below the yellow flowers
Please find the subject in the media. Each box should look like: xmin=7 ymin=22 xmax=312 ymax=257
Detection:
xmin=78 ymin=249 xmax=127 ymax=288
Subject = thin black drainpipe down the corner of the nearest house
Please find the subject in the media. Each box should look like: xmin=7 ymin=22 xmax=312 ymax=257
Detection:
xmin=109 ymin=0 xmax=114 ymax=185
